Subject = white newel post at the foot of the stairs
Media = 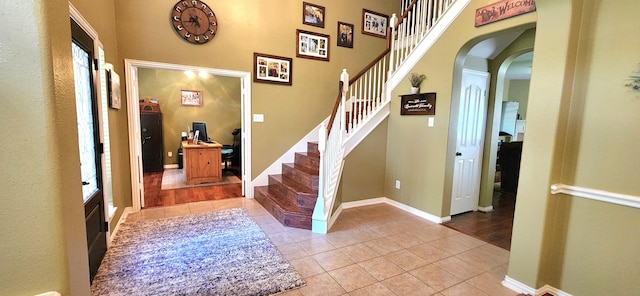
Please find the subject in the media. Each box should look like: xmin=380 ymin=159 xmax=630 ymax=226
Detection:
xmin=311 ymin=123 xmax=329 ymax=233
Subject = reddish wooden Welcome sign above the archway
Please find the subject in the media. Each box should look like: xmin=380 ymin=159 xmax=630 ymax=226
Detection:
xmin=476 ymin=0 xmax=536 ymax=27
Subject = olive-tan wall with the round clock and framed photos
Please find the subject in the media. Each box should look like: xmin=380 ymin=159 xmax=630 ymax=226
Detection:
xmin=115 ymin=0 xmax=400 ymax=178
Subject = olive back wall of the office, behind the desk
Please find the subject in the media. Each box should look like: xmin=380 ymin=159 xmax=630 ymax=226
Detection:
xmin=138 ymin=68 xmax=241 ymax=165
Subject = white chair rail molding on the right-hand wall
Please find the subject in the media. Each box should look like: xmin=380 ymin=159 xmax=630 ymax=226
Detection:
xmin=551 ymin=183 xmax=640 ymax=209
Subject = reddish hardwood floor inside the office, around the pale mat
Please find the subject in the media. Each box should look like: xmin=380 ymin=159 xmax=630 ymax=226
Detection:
xmin=144 ymin=172 xmax=242 ymax=208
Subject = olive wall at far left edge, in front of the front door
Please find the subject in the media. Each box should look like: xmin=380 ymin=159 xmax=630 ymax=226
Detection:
xmin=0 ymin=1 xmax=97 ymax=295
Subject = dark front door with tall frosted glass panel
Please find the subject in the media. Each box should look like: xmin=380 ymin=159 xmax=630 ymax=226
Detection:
xmin=71 ymin=20 xmax=107 ymax=281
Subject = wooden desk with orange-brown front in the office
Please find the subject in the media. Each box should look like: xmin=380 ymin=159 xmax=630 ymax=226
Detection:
xmin=182 ymin=141 xmax=222 ymax=185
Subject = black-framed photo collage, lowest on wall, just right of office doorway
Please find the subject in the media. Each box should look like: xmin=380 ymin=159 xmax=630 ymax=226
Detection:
xmin=253 ymin=52 xmax=293 ymax=85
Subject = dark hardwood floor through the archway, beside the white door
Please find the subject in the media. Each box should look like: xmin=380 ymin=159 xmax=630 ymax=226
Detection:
xmin=442 ymin=191 xmax=516 ymax=250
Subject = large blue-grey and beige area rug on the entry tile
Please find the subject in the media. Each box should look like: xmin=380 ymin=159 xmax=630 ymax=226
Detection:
xmin=91 ymin=208 xmax=305 ymax=296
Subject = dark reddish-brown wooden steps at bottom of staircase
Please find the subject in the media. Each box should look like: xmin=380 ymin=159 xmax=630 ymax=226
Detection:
xmin=254 ymin=142 xmax=320 ymax=229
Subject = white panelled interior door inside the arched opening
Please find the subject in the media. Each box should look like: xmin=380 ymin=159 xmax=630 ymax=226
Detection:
xmin=451 ymin=69 xmax=489 ymax=215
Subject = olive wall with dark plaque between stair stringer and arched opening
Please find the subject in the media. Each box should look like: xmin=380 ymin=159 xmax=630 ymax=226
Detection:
xmin=385 ymin=1 xmax=536 ymax=217
